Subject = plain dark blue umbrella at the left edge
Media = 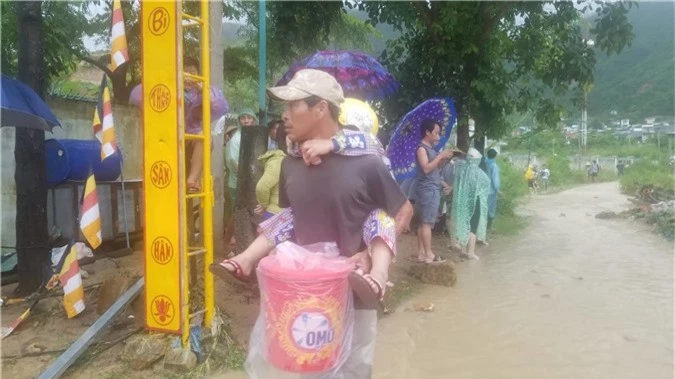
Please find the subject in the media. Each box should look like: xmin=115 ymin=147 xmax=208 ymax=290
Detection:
xmin=0 ymin=75 xmax=61 ymax=131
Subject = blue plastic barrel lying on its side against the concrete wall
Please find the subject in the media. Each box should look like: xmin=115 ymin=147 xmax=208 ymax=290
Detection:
xmin=45 ymin=139 xmax=122 ymax=187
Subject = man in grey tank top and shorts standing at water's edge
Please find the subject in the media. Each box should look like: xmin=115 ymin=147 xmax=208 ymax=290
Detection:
xmin=414 ymin=119 xmax=452 ymax=263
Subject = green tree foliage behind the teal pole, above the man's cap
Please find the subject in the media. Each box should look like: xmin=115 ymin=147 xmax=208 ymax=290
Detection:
xmin=225 ymin=1 xmax=381 ymax=113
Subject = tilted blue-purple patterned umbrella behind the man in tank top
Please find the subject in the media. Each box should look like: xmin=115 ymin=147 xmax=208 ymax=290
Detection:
xmin=387 ymin=97 xmax=457 ymax=182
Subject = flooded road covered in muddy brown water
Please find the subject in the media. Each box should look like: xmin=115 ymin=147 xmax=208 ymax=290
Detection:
xmin=374 ymin=183 xmax=673 ymax=379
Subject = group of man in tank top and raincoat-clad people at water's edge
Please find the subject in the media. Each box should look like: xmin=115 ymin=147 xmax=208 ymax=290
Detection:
xmin=403 ymin=119 xmax=500 ymax=263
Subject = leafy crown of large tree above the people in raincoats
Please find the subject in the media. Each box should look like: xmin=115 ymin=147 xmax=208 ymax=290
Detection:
xmin=358 ymin=0 xmax=632 ymax=148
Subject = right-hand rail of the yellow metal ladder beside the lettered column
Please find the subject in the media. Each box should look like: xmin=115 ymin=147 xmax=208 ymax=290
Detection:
xmin=199 ymin=0 xmax=214 ymax=328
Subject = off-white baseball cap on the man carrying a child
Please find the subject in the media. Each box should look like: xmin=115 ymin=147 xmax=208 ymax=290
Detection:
xmin=267 ymin=68 xmax=345 ymax=107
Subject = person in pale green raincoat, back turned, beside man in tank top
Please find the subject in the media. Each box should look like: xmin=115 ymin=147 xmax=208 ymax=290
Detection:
xmin=452 ymin=148 xmax=490 ymax=259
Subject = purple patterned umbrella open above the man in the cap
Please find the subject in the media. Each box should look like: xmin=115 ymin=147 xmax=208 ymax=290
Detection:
xmin=277 ymin=50 xmax=400 ymax=100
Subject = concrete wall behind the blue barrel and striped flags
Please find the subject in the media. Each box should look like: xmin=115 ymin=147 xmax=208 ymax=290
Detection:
xmin=0 ymin=97 xmax=143 ymax=246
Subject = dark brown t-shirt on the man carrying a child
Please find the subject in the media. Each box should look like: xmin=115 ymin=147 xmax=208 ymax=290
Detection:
xmin=279 ymin=154 xmax=407 ymax=257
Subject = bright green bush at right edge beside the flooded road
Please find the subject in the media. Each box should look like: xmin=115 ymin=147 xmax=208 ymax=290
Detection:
xmin=619 ymin=159 xmax=674 ymax=196
